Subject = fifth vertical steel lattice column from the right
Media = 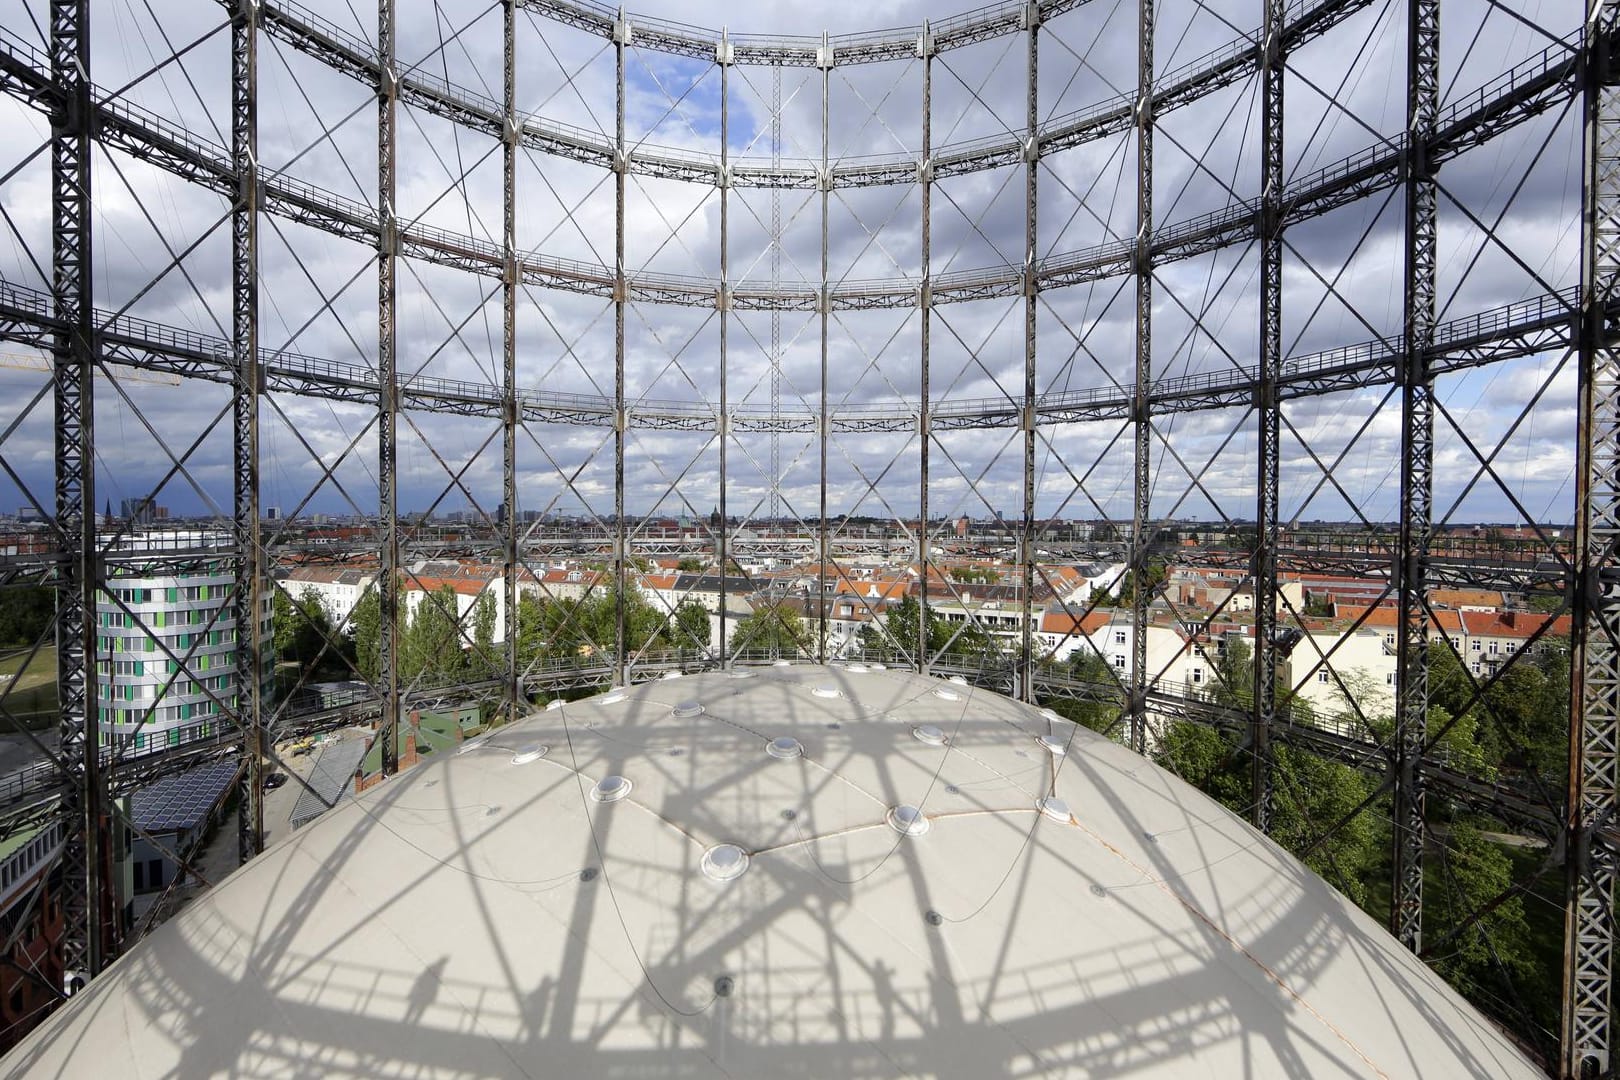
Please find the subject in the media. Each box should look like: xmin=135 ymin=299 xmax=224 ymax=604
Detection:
xmin=1014 ymin=0 xmax=1040 ymax=701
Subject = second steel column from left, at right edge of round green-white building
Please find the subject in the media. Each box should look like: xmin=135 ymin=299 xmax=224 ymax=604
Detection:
xmin=230 ymin=0 xmax=266 ymax=863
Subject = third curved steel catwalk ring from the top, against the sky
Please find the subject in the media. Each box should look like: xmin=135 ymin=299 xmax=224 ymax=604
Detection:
xmin=0 ymin=29 xmax=1576 ymax=311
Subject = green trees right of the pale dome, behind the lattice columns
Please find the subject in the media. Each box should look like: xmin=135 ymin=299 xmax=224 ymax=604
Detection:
xmin=1048 ymin=641 xmax=1570 ymax=1025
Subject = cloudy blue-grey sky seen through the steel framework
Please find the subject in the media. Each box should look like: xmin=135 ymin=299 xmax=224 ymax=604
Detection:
xmin=0 ymin=0 xmax=1580 ymax=540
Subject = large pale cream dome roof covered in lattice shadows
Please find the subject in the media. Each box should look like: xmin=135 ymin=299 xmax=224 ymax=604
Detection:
xmin=0 ymin=667 xmax=1541 ymax=1080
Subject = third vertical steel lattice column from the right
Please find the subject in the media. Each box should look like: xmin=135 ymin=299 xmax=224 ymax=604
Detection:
xmin=1251 ymin=0 xmax=1286 ymax=832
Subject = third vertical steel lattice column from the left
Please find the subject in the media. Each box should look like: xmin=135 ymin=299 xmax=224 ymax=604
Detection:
xmin=377 ymin=0 xmax=403 ymax=776
